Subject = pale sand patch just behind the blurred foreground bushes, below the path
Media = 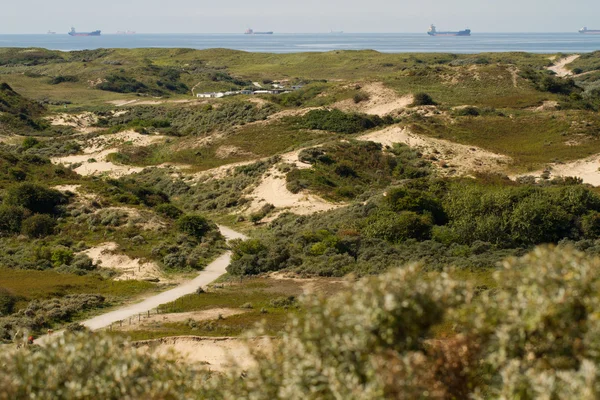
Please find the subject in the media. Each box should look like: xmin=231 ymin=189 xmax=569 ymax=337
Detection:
xmin=134 ymin=336 xmax=272 ymax=371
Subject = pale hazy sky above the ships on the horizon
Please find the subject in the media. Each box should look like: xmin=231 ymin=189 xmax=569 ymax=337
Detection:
xmin=0 ymin=0 xmax=600 ymax=33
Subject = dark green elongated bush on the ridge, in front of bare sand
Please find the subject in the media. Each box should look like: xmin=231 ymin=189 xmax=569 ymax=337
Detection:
xmin=300 ymin=109 xmax=393 ymax=133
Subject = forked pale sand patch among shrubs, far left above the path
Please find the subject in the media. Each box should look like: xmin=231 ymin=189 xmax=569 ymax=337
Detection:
xmin=51 ymin=131 xmax=164 ymax=178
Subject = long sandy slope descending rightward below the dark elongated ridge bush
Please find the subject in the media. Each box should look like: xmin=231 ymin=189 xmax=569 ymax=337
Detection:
xmin=359 ymin=126 xmax=511 ymax=175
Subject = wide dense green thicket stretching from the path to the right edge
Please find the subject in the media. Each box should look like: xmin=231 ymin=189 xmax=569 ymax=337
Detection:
xmin=230 ymin=175 xmax=600 ymax=276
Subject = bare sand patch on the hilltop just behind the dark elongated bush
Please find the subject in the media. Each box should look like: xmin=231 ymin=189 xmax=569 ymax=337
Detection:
xmin=332 ymin=82 xmax=413 ymax=117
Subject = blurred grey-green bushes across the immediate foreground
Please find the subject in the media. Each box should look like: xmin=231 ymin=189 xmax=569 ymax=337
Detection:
xmin=0 ymin=247 xmax=600 ymax=400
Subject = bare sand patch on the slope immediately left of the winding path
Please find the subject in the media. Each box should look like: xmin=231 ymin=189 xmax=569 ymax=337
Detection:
xmin=80 ymin=242 xmax=164 ymax=281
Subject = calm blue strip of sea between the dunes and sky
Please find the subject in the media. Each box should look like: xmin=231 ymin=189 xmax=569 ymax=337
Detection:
xmin=0 ymin=32 xmax=600 ymax=53
